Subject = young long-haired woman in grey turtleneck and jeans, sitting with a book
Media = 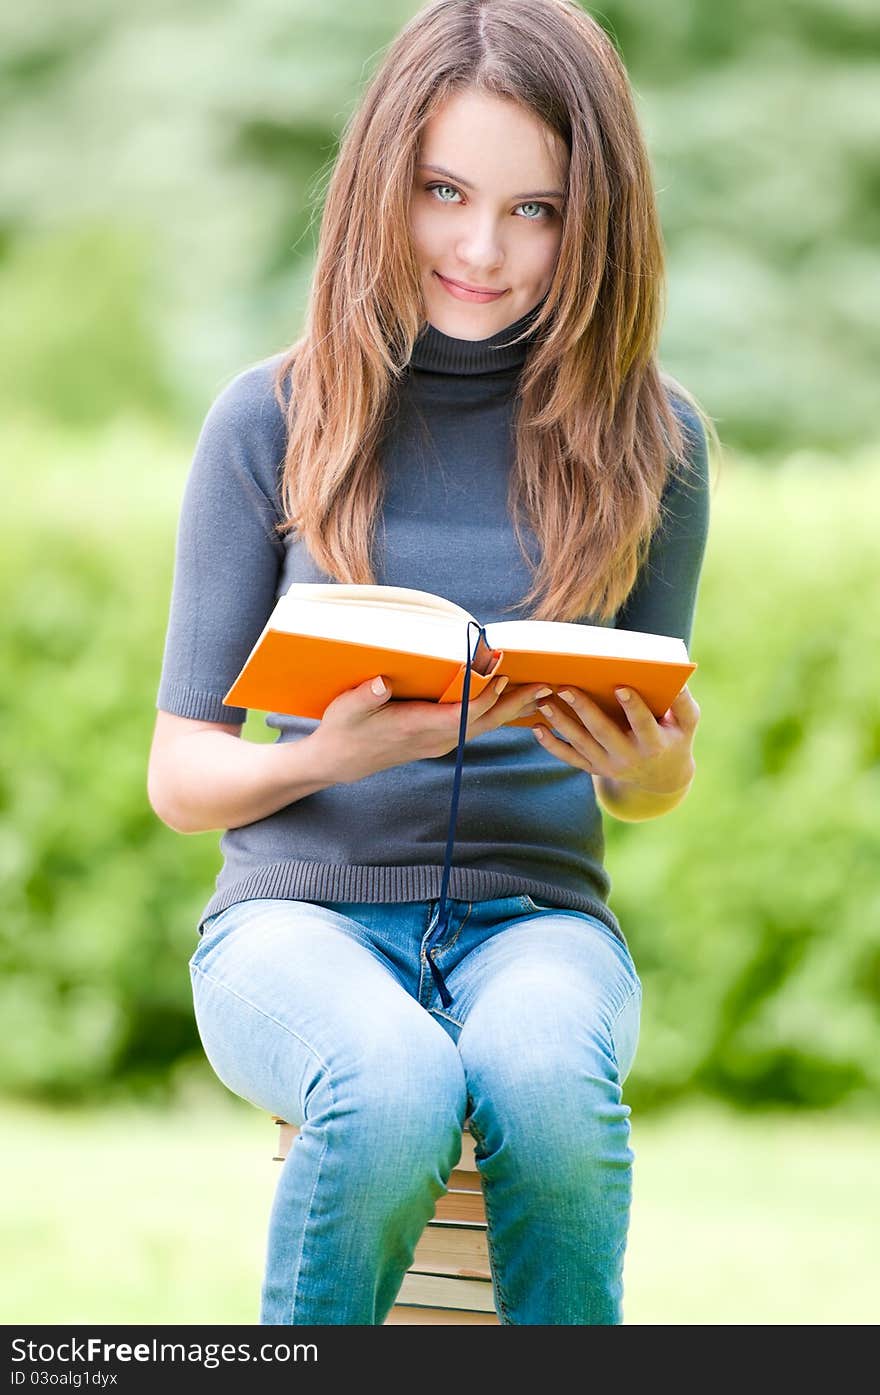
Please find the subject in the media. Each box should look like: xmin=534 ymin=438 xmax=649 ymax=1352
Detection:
xmin=149 ymin=0 xmax=715 ymax=1325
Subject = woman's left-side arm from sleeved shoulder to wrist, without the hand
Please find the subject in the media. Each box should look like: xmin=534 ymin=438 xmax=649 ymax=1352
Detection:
xmin=148 ymin=360 xmax=336 ymax=833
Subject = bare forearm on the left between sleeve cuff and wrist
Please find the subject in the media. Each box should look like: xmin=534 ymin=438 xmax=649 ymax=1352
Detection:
xmin=151 ymin=731 xmax=337 ymax=833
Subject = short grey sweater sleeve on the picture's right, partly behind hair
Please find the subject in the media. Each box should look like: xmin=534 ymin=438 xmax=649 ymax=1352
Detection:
xmin=615 ymin=398 xmax=710 ymax=649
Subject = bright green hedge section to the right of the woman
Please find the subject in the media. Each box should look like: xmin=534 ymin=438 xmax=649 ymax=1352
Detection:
xmin=608 ymin=460 xmax=880 ymax=1106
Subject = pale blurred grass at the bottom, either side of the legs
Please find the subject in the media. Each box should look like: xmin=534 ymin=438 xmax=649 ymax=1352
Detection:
xmin=0 ymin=1088 xmax=880 ymax=1325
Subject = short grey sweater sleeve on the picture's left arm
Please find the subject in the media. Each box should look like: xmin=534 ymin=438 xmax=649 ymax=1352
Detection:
xmin=156 ymin=359 xmax=286 ymax=724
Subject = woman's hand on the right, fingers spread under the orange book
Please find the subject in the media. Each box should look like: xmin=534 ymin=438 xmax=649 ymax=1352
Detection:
xmin=534 ymin=686 xmax=700 ymax=794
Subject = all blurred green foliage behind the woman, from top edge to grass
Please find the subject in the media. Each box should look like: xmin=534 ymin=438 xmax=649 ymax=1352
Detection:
xmin=0 ymin=0 xmax=880 ymax=1109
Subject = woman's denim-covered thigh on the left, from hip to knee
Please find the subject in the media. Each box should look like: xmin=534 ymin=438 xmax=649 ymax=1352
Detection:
xmin=190 ymin=898 xmax=466 ymax=1124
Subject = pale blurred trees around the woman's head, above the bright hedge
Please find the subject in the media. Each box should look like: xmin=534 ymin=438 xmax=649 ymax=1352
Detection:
xmin=0 ymin=0 xmax=880 ymax=456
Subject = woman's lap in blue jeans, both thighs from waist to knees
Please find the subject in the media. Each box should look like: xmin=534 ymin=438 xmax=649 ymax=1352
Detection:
xmin=190 ymin=897 xmax=642 ymax=1123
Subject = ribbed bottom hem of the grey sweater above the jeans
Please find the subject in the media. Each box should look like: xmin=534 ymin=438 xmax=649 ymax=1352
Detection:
xmin=198 ymin=862 xmax=626 ymax=944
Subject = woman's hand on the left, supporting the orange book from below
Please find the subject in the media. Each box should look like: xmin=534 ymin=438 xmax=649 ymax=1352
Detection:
xmin=307 ymin=678 xmax=548 ymax=784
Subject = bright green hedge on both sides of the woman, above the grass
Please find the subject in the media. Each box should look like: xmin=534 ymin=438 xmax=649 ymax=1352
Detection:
xmin=0 ymin=420 xmax=880 ymax=1109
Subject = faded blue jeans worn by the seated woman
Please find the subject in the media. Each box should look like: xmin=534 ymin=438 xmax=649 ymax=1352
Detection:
xmin=190 ymin=896 xmax=642 ymax=1325
